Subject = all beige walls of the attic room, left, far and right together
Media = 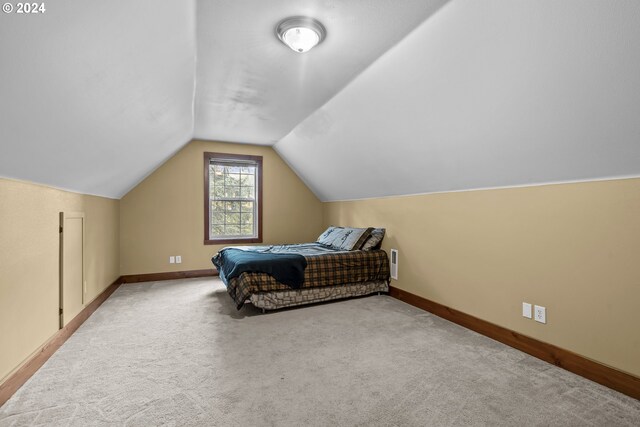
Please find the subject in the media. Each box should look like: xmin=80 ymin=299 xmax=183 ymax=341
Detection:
xmin=0 ymin=141 xmax=640 ymax=384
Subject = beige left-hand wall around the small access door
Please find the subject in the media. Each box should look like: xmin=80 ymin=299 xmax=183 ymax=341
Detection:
xmin=0 ymin=178 xmax=119 ymax=382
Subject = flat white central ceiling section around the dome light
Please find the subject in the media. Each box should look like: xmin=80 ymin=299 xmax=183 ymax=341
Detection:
xmin=195 ymin=0 xmax=446 ymax=145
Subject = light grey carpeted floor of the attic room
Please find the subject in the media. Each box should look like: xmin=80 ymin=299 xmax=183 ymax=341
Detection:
xmin=0 ymin=278 xmax=640 ymax=426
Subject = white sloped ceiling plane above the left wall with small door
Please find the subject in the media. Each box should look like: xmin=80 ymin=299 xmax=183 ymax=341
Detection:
xmin=0 ymin=0 xmax=196 ymax=198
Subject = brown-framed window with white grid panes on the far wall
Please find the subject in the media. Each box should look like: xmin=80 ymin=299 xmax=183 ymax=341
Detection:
xmin=204 ymin=153 xmax=262 ymax=245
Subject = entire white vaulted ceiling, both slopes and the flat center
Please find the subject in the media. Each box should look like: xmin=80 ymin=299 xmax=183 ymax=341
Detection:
xmin=0 ymin=0 xmax=640 ymax=200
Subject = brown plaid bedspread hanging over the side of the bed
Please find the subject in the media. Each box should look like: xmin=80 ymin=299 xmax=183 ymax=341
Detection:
xmin=223 ymin=250 xmax=389 ymax=310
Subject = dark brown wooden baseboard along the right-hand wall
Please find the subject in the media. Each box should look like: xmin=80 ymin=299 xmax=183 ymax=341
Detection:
xmin=389 ymin=286 xmax=640 ymax=399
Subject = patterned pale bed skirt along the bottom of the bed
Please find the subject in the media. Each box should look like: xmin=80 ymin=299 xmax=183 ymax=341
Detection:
xmin=249 ymin=280 xmax=389 ymax=310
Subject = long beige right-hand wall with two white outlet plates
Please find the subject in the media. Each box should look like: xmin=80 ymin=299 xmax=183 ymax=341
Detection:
xmin=324 ymin=179 xmax=640 ymax=376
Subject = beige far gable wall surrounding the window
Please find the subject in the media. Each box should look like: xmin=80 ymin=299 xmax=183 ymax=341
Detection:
xmin=120 ymin=141 xmax=322 ymax=275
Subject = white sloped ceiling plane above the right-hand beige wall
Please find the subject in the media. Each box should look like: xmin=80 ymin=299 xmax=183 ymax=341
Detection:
xmin=275 ymin=0 xmax=640 ymax=201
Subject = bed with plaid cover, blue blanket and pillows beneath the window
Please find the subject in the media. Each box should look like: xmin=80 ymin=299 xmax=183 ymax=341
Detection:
xmin=212 ymin=227 xmax=389 ymax=312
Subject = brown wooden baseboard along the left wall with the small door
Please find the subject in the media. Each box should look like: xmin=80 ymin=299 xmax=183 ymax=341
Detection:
xmin=0 ymin=277 xmax=122 ymax=406
